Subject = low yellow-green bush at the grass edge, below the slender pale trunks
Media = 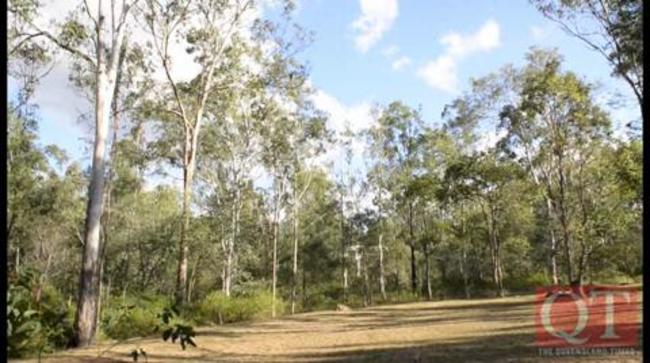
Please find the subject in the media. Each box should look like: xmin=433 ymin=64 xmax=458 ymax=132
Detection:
xmin=194 ymin=291 xmax=286 ymax=324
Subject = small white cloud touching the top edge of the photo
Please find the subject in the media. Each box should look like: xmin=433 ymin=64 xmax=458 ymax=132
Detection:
xmin=352 ymin=0 xmax=399 ymax=53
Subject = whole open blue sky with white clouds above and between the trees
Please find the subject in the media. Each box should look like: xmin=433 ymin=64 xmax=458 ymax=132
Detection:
xmin=10 ymin=0 xmax=639 ymax=186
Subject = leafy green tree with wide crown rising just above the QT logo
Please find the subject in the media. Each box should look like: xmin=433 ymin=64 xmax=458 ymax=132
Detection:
xmin=501 ymin=52 xmax=611 ymax=283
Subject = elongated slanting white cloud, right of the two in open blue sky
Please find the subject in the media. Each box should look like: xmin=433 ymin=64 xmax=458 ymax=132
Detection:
xmin=417 ymin=20 xmax=500 ymax=93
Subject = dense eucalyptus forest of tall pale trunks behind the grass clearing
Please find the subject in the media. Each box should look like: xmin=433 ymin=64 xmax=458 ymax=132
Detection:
xmin=6 ymin=0 xmax=643 ymax=356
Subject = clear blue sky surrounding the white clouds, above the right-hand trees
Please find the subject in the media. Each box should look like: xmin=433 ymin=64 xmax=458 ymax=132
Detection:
xmin=298 ymin=0 xmax=638 ymax=128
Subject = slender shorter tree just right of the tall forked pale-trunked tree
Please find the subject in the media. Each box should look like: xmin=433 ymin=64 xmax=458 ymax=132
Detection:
xmin=198 ymin=77 xmax=265 ymax=296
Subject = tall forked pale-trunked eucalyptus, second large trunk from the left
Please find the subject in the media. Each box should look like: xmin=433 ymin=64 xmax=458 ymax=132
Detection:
xmin=140 ymin=0 xmax=254 ymax=303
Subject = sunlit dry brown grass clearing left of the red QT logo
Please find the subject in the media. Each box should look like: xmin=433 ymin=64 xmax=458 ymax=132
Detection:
xmin=12 ymin=295 xmax=641 ymax=363
